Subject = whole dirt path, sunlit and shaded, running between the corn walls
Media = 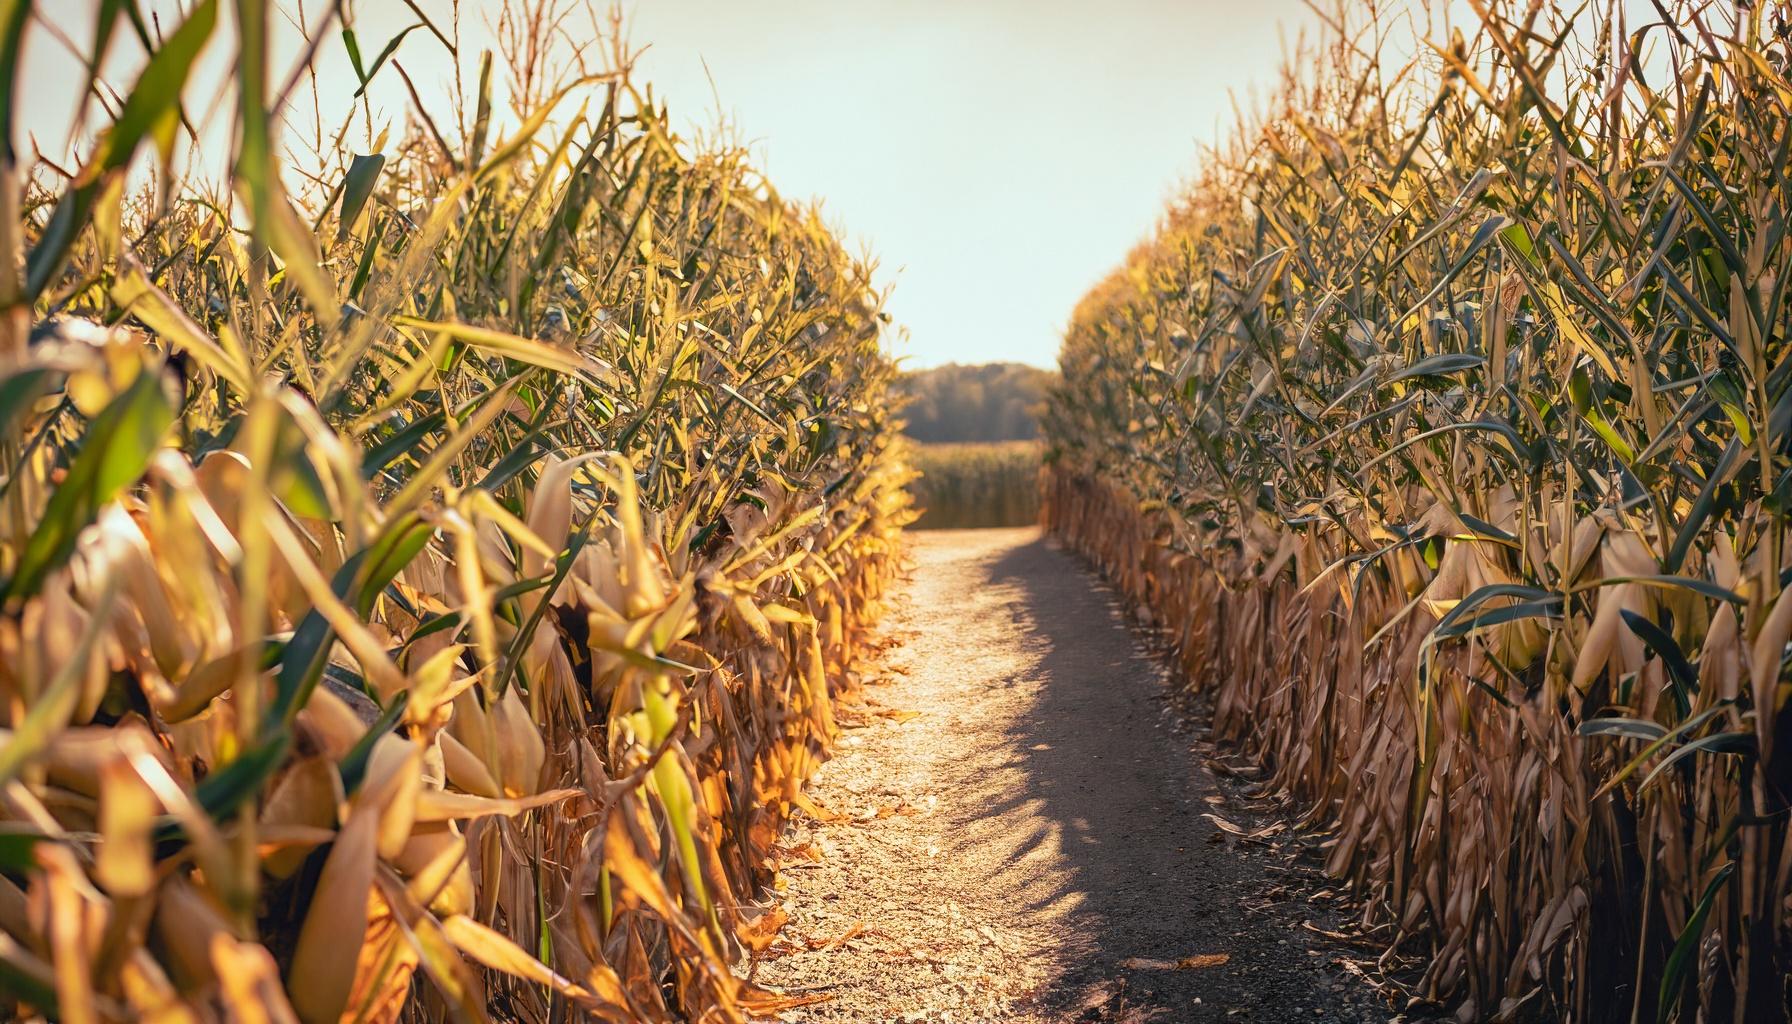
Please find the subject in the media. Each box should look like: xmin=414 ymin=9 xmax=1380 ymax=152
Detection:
xmin=756 ymin=529 xmax=1392 ymax=1022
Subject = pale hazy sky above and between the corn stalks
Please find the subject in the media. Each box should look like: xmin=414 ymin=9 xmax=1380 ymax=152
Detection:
xmin=23 ymin=0 xmax=1314 ymax=368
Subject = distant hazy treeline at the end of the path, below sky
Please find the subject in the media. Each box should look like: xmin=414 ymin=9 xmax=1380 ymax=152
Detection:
xmin=900 ymin=362 xmax=1057 ymax=443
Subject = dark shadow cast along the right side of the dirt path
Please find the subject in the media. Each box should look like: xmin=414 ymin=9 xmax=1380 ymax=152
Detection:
xmin=959 ymin=538 xmax=1389 ymax=1020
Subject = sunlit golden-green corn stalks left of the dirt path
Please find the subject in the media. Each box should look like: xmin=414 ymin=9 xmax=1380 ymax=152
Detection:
xmin=0 ymin=0 xmax=910 ymax=1024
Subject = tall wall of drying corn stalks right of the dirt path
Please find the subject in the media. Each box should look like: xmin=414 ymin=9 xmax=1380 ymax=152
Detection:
xmin=1045 ymin=0 xmax=1792 ymax=1020
